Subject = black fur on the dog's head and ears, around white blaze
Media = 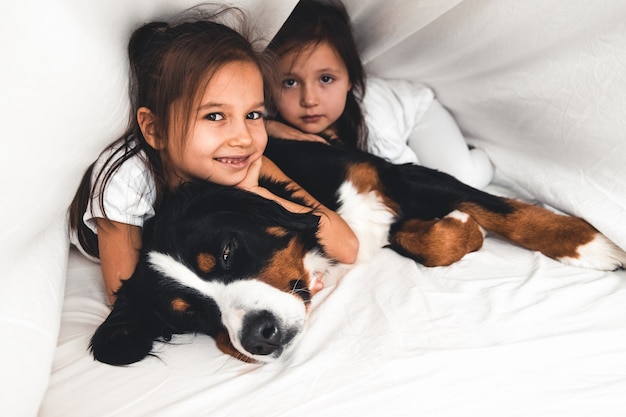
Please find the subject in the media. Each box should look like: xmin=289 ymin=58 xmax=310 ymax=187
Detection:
xmin=90 ymin=182 xmax=319 ymax=365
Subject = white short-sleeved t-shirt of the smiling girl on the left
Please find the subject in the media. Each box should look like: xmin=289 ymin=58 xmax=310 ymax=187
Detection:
xmin=70 ymin=144 xmax=156 ymax=259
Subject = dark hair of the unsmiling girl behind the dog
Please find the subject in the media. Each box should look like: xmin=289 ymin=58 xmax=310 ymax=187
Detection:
xmin=266 ymin=0 xmax=367 ymax=147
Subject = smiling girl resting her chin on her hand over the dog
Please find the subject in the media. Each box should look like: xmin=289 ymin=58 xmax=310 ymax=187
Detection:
xmin=70 ymin=9 xmax=358 ymax=302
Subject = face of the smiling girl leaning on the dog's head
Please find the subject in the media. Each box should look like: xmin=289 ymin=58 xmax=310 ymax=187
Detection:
xmin=162 ymin=62 xmax=267 ymax=187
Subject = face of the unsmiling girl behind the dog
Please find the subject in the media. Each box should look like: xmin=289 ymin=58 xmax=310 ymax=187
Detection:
xmin=274 ymin=42 xmax=352 ymax=133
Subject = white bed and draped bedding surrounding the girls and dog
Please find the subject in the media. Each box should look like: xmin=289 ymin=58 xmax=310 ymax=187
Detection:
xmin=0 ymin=0 xmax=626 ymax=417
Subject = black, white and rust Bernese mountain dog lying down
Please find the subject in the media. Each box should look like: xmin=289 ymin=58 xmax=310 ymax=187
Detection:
xmin=90 ymin=139 xmax=626 ymax=365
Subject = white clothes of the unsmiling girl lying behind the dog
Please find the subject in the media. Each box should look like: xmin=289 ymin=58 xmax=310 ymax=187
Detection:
xmin=362 ymin=77 xmax=494 ymax=188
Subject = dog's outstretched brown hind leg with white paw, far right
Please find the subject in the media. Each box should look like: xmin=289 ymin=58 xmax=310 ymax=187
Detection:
xmin=460 ymin=200 xmax=626 ymax=271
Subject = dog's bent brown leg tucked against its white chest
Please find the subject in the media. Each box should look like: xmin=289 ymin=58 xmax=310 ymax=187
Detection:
xmin=389 ymin=210 xmax=484 ymax=266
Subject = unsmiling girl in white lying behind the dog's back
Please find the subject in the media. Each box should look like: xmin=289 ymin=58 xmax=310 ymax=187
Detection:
xmin=266 ymin=0 xmax=493 ymax=188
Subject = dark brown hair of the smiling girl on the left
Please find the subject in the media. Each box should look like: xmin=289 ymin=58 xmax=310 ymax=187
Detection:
xmin=69 ymin=8 xmax=268 ymax=256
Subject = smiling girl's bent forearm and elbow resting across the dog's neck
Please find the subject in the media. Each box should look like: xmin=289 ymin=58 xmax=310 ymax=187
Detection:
xmin=251 ymin=156 xmax=359 ymax=264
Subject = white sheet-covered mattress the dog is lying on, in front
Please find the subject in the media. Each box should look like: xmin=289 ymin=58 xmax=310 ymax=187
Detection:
xmin=40 ymin=228 xmax=626 ymax=417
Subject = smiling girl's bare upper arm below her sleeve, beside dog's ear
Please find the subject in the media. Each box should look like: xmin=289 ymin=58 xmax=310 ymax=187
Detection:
xmin=96 ymin=218 xmax=141 ymax=304
